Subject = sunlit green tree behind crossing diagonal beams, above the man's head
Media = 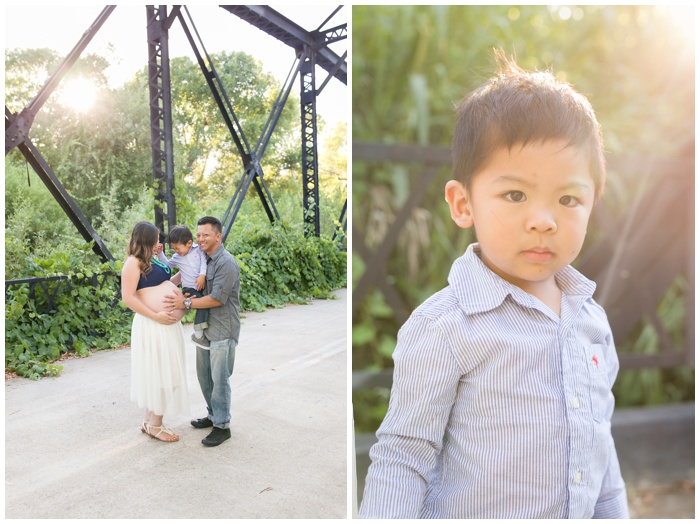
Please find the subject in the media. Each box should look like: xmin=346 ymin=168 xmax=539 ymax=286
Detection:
xmin=171 ymin=52 xmax=299 ymax=205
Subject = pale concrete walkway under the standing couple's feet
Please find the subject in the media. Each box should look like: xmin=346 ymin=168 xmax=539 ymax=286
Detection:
xmin=5 ymin=289 xmax=348 ymax=519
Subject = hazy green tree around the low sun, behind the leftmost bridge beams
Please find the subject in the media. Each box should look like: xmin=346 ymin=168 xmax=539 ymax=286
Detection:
xmin=6 ymin=49 xmax=152 ymax=222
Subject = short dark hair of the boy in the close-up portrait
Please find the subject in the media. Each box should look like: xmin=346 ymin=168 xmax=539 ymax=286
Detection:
xmin=452 ymin=50 xmax=605 ymax=199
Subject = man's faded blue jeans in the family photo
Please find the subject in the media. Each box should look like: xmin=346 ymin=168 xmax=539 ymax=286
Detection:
xmin=197 ymin=338 xmax=236 ymax=429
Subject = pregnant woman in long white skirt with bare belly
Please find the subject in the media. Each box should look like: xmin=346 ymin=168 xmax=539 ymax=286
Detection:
xmin=122 ymin=222 xmax=190 ymax=442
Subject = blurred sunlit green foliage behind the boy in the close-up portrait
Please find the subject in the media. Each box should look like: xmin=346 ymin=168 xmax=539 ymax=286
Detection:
xmin=351 ymin=5 xmax=695 ymax=432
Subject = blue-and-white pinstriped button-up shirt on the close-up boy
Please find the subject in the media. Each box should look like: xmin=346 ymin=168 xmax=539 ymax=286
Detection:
xmin=359 ymin=244 xmax=628 ymax=518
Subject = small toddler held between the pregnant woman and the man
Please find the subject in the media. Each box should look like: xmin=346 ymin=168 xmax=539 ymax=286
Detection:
xmin=158 ymin=226 xmax=209 ymax=348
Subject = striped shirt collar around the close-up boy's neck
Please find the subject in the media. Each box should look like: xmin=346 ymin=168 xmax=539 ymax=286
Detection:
xmin=447 ymin=242 xmax=596 ymax=314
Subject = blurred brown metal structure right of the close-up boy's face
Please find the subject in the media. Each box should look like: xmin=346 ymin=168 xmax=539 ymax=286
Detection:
xmin=577 ymin=144 xmax=695 ymax=369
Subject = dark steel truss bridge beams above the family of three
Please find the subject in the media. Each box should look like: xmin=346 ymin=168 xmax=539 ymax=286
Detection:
xmin=5 ymin=5 xmax=347 ymax=261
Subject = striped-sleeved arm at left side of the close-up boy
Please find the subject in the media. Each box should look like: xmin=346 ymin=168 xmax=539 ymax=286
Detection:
xmin=359 ymin=317 xmax=462 ymax=518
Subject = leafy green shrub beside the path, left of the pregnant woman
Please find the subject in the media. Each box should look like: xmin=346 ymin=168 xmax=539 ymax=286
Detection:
xmin=5 ymin=246 xmax=130 ymax=379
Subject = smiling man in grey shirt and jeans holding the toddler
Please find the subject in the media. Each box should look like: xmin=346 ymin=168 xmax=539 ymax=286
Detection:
xmin=166 ymin=216 xmax=241 ymax=447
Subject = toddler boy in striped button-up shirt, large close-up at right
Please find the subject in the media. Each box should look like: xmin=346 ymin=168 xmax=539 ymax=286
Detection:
xmin=359 ymin=53 xmax=628 ymax=519
